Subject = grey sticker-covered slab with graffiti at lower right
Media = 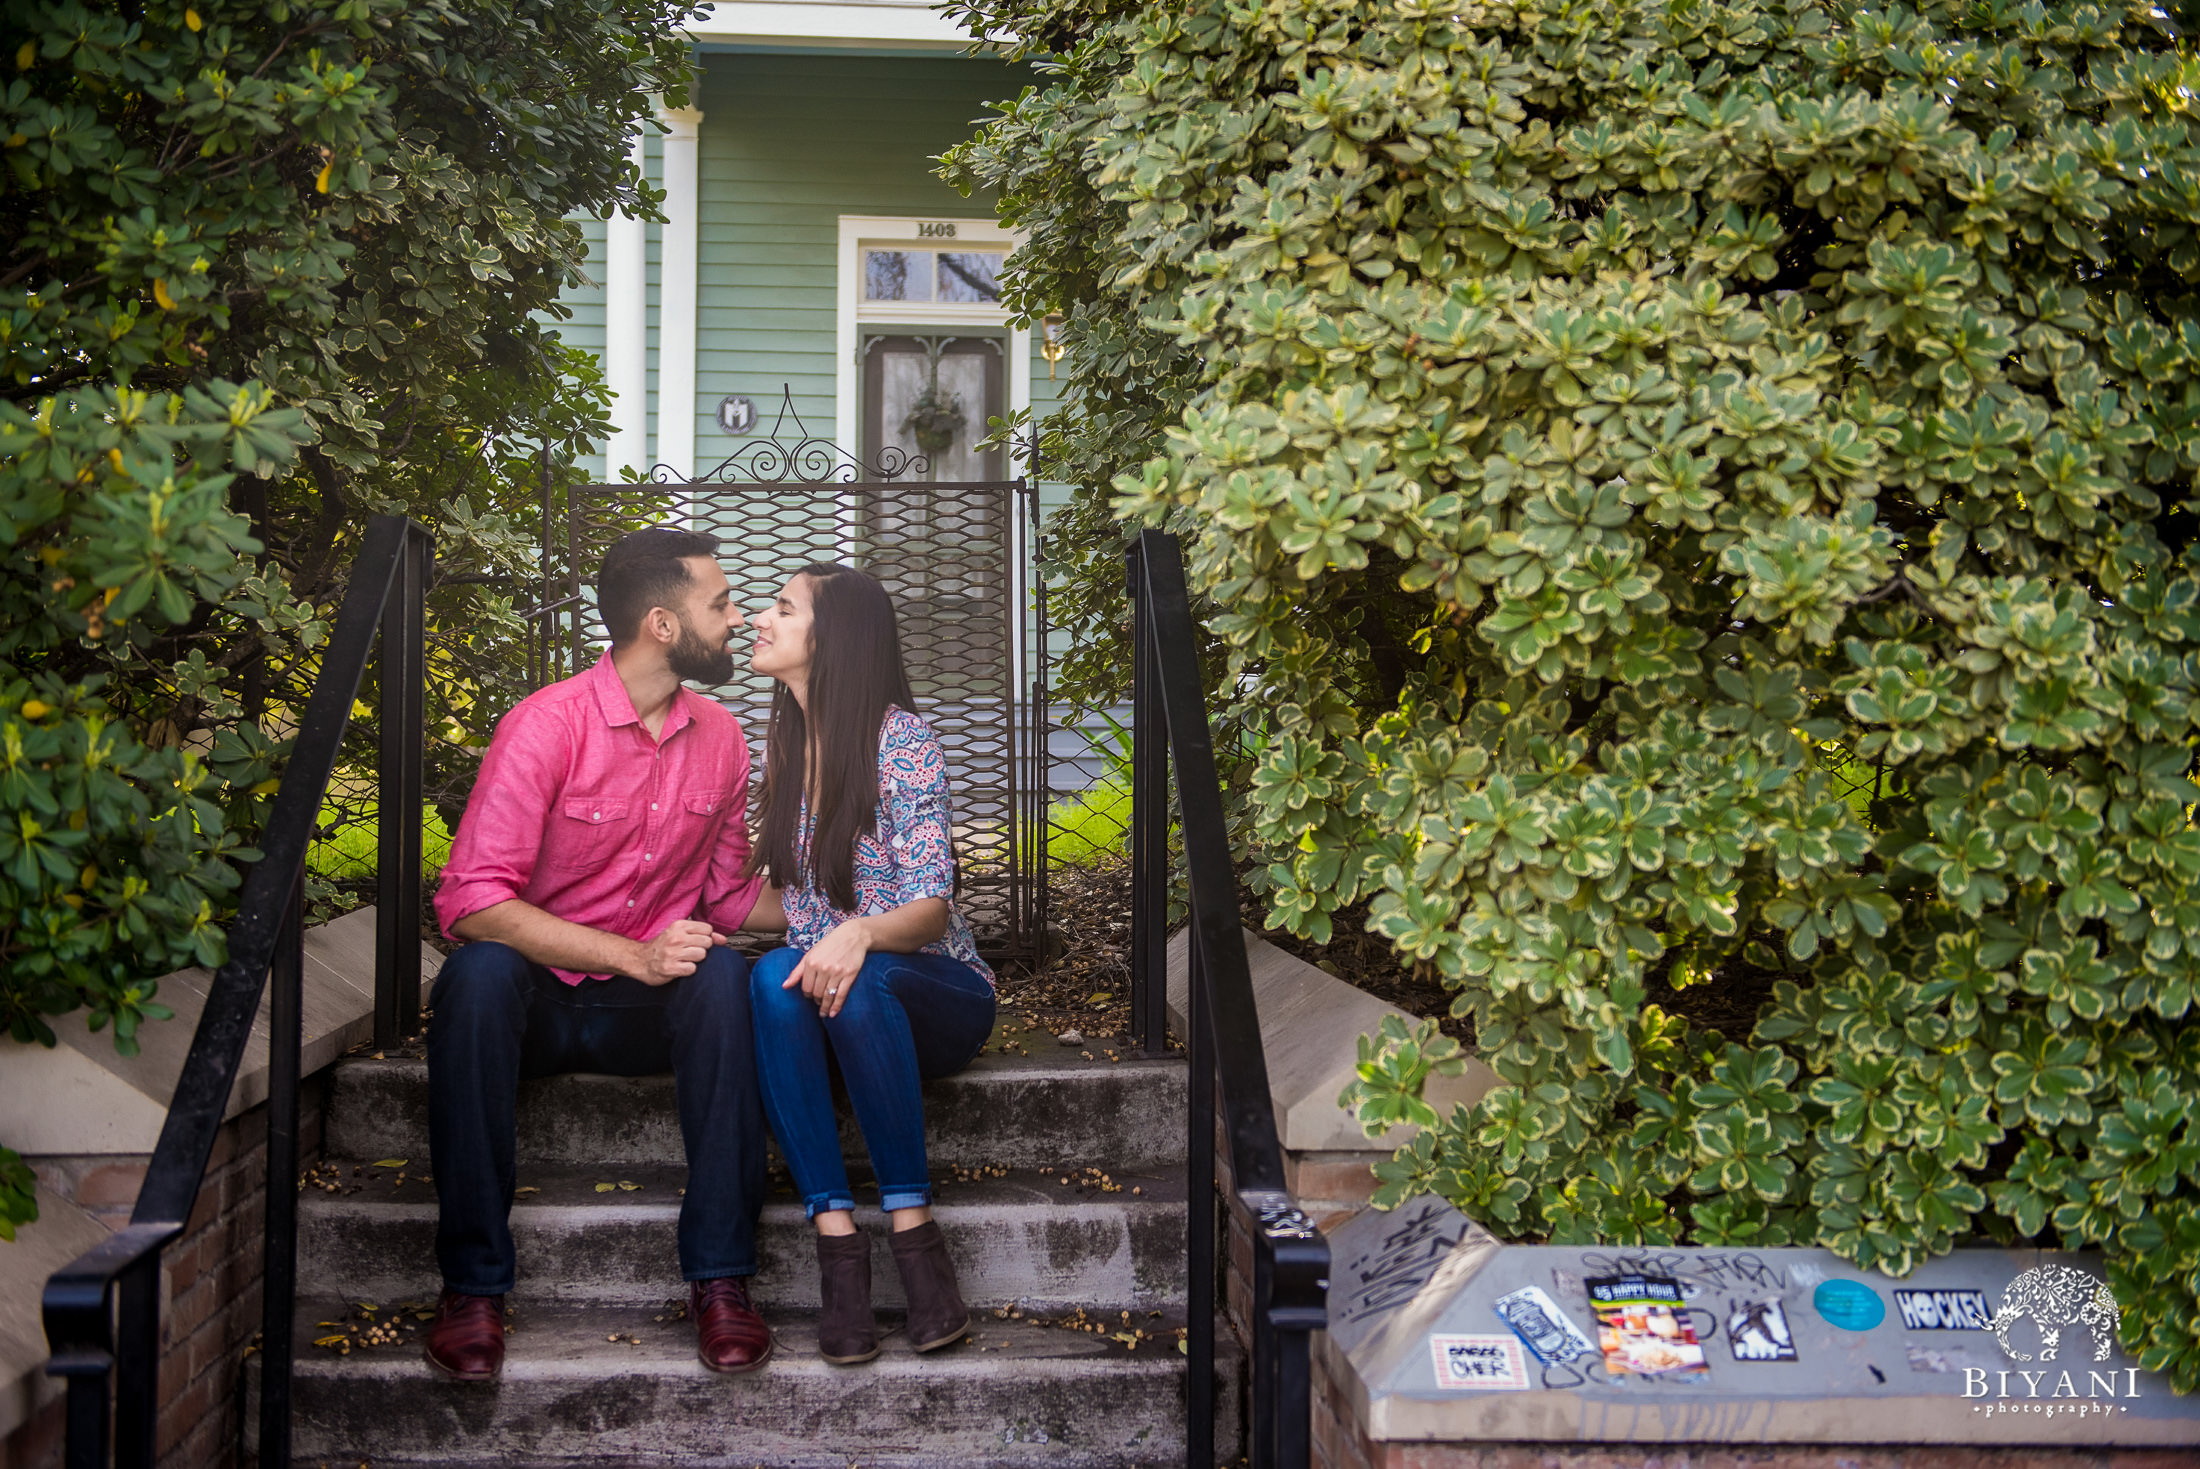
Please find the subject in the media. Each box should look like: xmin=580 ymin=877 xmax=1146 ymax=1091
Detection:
xmin=1320 ymin=1196 xmax=2200 ymax=1445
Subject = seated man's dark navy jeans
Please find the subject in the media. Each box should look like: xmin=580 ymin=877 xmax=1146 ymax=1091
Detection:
xmin=427 ymin=943 xmax=763 ymax=1295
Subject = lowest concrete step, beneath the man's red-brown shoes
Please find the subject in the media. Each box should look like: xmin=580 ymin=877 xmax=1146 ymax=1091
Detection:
xmin=270 ymin=1302 xmax=1243 ymax=1469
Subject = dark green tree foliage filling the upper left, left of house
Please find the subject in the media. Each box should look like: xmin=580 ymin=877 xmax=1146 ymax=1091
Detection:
xmin=0 ymin=0 xmax=691 ymax=1049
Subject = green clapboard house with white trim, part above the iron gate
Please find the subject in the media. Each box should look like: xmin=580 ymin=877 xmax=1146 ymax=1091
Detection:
xmin=561 ymin=0 xmax=1049 ymax=482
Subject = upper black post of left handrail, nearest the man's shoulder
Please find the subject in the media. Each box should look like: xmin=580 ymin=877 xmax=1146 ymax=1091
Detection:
xmin=374 ymin=526 xmax=433 ymax=1049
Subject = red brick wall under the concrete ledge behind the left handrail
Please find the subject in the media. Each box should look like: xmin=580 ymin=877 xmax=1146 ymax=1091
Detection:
xmin=0 ymin=1078 xmax=326 ymax=1469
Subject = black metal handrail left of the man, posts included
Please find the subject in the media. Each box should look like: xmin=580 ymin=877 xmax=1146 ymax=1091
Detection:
xmin=42 ymin=515 xmax=433 ymax=1469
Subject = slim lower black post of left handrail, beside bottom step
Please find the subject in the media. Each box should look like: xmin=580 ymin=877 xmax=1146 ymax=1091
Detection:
xmin=260 ymin=870 xmax=310 ymax=1469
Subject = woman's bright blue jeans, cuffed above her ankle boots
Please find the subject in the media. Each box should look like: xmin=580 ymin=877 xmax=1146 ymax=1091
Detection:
xmin=748 ymin=948 xmax=992 ymax=1218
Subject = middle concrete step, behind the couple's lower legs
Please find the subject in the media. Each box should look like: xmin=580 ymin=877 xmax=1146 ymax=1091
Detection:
xmin=297 ymin=1161 xmax=1186 ymax=1311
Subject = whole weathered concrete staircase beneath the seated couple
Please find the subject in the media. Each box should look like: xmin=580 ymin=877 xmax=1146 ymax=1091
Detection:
xmin=272 ymin=1042 xmax=1236 ymax=1469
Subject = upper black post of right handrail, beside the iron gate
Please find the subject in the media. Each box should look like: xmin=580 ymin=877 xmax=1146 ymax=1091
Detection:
xmin=1124 ymin=541 xmax=1168 ymax=1056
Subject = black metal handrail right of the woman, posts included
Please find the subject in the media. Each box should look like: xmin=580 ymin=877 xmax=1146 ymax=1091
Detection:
xmin=1129 ymin=530 xmax=1329 ymax=1469
